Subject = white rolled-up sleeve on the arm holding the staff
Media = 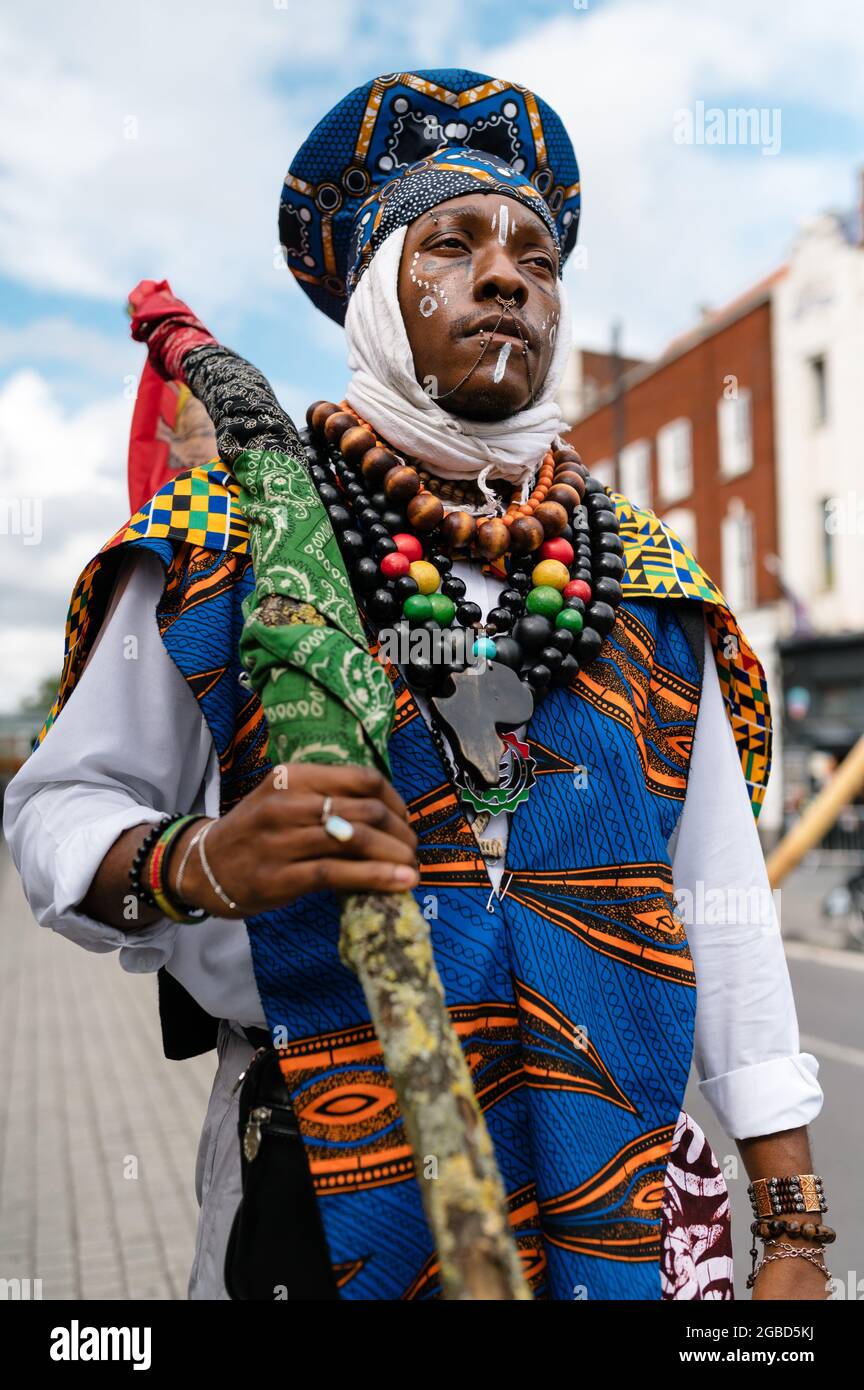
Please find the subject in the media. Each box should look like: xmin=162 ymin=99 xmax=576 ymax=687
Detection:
xmin=3 ymin=552 xmax=218 ymax=973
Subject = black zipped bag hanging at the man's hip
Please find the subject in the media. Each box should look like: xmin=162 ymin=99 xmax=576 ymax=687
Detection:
xmin=225 ymin=1047 xmax=339 ymax=1302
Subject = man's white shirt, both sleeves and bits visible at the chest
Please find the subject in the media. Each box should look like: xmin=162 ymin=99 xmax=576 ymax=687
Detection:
xmin=4 ymin=552 xmax=822 ymax=1138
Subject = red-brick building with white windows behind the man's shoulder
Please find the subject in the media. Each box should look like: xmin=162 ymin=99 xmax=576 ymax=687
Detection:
xmin=563 ymin=271 xmax=783 ymax=614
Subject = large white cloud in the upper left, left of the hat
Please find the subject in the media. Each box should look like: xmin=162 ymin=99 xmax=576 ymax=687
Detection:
xmin=0 ymin=0 xmax=350 ymax=304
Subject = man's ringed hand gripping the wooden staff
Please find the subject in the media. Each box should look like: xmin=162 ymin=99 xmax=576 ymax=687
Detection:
xmin=171 ymin=763 xmax=419 ymax=917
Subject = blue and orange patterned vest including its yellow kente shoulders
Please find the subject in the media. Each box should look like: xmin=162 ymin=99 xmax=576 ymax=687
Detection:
xmin=40 ymin=461 xmax=771 ymax=1300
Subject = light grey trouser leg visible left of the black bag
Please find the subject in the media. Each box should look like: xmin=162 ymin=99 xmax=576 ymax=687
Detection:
xmin=189 ymin=1020 xmax=254 ymax=1300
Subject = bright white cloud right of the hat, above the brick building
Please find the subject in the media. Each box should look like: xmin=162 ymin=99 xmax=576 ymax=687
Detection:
xmin=467 ymin=0 xmax=864 ymax=352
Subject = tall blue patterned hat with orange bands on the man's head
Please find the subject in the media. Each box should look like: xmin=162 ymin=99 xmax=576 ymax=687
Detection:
xmin=279 ymin=68 xmax=579 ymax=324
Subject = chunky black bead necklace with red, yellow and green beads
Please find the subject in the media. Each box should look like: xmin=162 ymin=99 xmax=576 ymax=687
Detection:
xmin=304 ymin=403 xmax=625 ymax=699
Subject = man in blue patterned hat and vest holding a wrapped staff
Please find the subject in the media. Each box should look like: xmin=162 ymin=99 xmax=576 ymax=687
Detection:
xmin=7 ymin=71 xmax=826 ymax=1300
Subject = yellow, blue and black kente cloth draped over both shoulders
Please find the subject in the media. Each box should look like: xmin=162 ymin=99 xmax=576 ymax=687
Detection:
xmin=36 ymin=459 xmax=772 ymax=816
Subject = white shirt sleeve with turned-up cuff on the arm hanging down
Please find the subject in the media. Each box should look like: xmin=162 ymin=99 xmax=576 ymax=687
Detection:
xmin=670 ymin=630 xmax=822 ymax=1138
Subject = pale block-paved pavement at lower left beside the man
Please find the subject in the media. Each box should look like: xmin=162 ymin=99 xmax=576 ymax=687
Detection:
xmin=0 ymin=847 xmax=215 ymax=1300
